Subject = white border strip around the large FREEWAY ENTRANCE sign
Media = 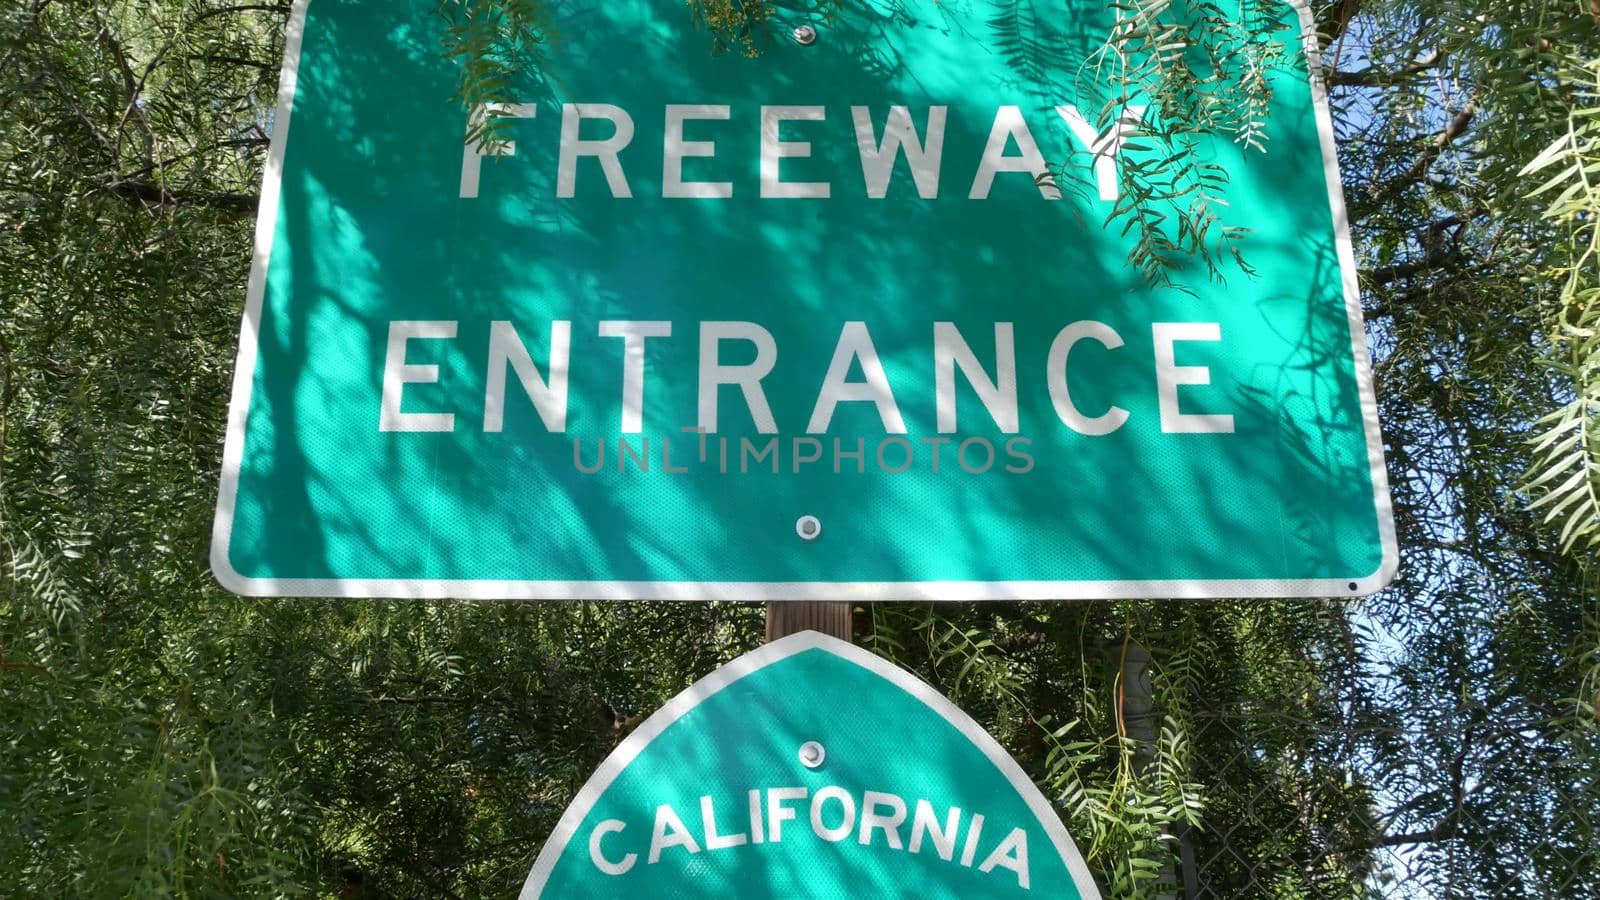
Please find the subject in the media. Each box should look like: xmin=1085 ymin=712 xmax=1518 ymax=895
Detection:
xmin=211 ymin=0 xmax=1400 ymax=601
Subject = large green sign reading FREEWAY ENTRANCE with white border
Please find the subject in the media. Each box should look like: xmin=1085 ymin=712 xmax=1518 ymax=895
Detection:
xmin=213 ymin=0 xmax=1395 ymax=599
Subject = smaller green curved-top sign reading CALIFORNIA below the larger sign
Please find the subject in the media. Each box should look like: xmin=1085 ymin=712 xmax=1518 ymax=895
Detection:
xmin=522 ymin=631 xmax=1099 ymax=900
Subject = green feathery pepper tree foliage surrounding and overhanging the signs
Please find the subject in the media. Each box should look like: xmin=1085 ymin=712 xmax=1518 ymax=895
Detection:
xmin=9 ymin=0 xmax=1600 ymax=897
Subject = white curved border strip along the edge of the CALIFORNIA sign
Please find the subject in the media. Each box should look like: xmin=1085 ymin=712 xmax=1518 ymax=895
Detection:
xmin=518 ymin=631 xmax=1101 ymax=900
